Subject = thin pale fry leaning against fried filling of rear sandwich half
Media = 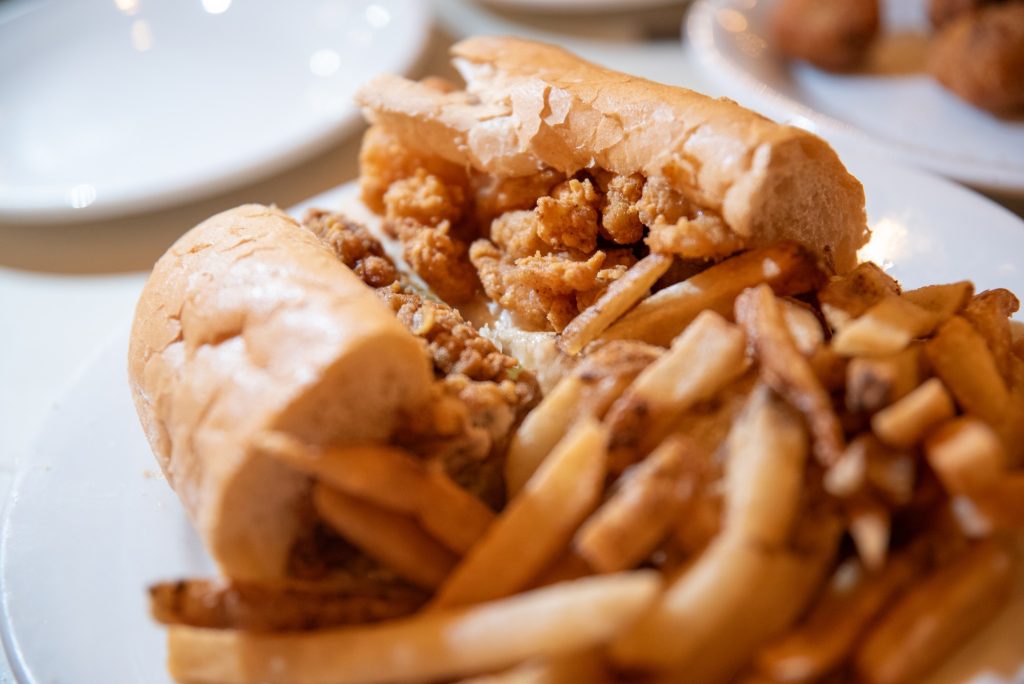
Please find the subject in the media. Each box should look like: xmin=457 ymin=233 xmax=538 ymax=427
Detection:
xmin=558 ymin=253 xmax=673 ymax=355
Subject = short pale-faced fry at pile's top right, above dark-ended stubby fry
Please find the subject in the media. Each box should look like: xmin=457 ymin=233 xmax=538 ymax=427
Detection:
xmin=831 ymin=296 xmax=940 ymax=356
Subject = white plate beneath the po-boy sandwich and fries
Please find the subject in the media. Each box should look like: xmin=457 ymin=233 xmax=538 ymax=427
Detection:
xmin=0 ymin=155 xmax=1024 ymax=684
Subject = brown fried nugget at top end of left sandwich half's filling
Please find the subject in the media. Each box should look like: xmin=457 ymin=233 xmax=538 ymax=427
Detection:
xmin=302 ymin=209 xmax=398 ymax=288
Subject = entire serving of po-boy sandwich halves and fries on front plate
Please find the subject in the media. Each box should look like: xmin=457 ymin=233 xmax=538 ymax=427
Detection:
xmin=131 ymin=34 xmax=1024 ymax=684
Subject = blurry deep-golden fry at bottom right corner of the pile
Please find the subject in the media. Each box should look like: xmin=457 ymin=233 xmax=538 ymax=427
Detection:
xmin=854 ymin=542 xmax=1014 ymax=684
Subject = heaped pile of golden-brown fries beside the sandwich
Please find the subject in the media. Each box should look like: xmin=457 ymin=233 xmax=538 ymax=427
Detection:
xmin=163 ymin=243 xmax=1024 ymax=684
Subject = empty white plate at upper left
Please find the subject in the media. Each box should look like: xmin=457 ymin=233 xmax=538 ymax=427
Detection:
xmin=0 ymin=0 xmax=430 ymax=220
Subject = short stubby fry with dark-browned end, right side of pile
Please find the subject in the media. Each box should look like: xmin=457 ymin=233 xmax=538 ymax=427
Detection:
xmin=846 ymin=346 xmax=922 ymax=414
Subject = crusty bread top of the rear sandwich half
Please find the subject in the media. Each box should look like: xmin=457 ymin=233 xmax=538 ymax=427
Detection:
xmin=357 ymin=38 xmax=868 ymax=271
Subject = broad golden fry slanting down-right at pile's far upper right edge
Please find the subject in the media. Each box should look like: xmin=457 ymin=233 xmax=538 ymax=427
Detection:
xmin=925 ymin=316 xmax=1011 ymax=425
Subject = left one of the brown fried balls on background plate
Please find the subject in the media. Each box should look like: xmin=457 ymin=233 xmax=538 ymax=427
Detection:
xmin=772 ymin=0 xmax=880 ymax=72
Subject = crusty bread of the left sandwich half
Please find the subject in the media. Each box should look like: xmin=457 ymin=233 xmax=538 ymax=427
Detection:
xmin=129 ymin=205 xmax=433 ymax=582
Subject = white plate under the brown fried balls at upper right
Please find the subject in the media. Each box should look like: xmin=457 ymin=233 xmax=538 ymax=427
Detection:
xmin=686 ymin=0 xmax=1024 ymax=195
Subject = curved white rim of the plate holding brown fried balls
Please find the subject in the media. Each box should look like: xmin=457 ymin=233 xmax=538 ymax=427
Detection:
xmin=682 ymin=0 xmax=1024 ymax=197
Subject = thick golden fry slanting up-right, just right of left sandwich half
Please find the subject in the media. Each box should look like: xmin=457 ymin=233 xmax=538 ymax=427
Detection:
xmin=433 ymin=419 xmax=608 ymax=608
